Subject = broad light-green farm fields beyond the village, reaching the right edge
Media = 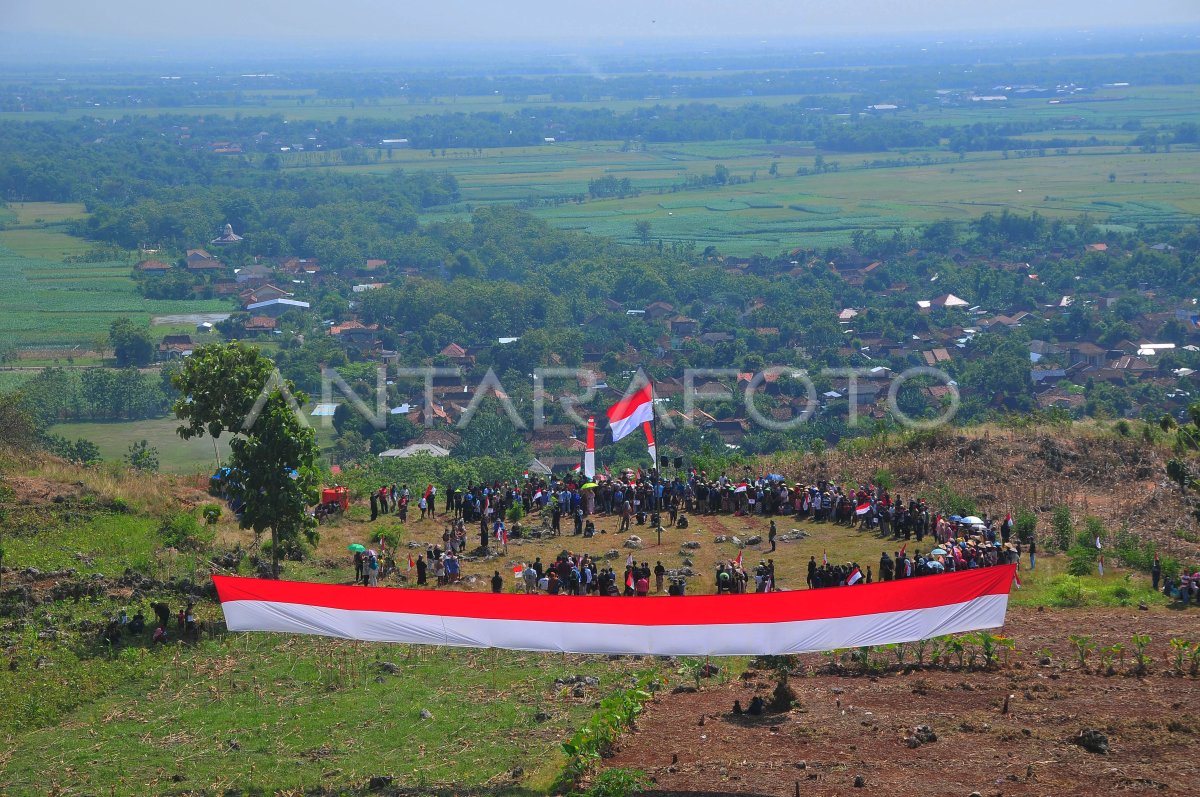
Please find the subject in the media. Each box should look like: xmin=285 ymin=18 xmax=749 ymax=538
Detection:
xmin=314 ymin=140 xmax=1200 ymax=254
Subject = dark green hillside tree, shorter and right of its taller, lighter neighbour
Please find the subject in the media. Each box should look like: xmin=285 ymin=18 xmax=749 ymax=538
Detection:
xmin=229 ymin=389 xmax=319 ymax=579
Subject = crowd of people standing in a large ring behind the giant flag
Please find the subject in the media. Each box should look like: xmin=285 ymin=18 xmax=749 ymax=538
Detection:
xmin=343 ymin=469 xmax=1046 ymax=597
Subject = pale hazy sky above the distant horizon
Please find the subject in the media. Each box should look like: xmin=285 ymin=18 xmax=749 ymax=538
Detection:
xmin=7 ymin=0 xmax=1200 ymax=43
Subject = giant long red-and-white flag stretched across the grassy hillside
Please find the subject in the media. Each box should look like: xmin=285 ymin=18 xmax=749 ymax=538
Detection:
xmin=212 ymin=565 xmax=1016 ymax=655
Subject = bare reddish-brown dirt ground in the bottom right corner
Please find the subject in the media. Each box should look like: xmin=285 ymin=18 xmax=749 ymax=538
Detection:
xmin=605 ymin=609 xmax=1200 ymax=797
